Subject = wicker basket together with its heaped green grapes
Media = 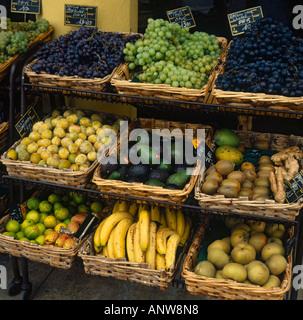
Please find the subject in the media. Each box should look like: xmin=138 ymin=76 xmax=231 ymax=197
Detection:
xmin=111 ymin=19 xmax=227 ymax=101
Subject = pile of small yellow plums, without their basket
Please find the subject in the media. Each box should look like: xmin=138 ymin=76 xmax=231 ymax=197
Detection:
xmin=7 ymin=109 xmax=120 ymax=171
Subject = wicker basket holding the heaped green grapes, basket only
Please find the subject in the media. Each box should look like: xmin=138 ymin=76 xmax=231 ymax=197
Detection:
xmin=111 ymin=37 xmax=227 ymax=108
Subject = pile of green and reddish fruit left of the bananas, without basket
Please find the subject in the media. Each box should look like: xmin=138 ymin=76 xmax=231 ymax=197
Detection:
xmin=3 ymin=193 xmax=103 ymax=249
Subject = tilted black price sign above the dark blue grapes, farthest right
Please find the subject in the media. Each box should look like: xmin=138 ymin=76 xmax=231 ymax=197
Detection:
xmin=227 ymin=6 xmax=263 ymax=36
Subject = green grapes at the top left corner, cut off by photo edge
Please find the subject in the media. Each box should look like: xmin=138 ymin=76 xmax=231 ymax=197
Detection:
xmin=0 ymin=19 xmax=50 ymax=64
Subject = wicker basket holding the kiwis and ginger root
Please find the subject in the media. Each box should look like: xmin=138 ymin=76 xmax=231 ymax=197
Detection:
xmin=195 ymin=131 xmax=303 ymax=220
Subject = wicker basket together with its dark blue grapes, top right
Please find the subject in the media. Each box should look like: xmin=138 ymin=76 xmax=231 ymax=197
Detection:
xmin=212 ymin=18 xmax=303 ymax=110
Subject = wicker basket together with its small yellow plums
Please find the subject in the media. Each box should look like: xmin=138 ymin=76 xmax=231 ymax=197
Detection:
xmin=1 ymin=108 xmax=127 ymax=187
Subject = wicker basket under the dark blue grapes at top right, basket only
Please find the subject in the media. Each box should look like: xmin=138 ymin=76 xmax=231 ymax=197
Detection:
xmin=212 ymin=41 xmax=303 ymax=112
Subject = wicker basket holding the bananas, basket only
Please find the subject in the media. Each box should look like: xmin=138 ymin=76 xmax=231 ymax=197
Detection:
xmin=78 ymin=225 xmax=193 ymax=290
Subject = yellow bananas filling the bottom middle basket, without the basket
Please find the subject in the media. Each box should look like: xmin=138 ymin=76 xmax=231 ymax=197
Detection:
xmin=94 ymin=200 xmax=192 ymax=271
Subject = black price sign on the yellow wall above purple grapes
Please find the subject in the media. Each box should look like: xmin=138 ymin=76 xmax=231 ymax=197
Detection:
xmin=64 ymin=4 xmax=97 ymax=27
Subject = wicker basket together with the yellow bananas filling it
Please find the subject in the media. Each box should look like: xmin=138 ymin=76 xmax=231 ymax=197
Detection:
xmin=78 ymin=200 xmax=192 ymax=290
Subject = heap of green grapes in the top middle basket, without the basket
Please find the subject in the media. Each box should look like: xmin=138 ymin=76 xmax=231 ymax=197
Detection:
xmin=123 ymin=18 xmax=221 ymax=89
